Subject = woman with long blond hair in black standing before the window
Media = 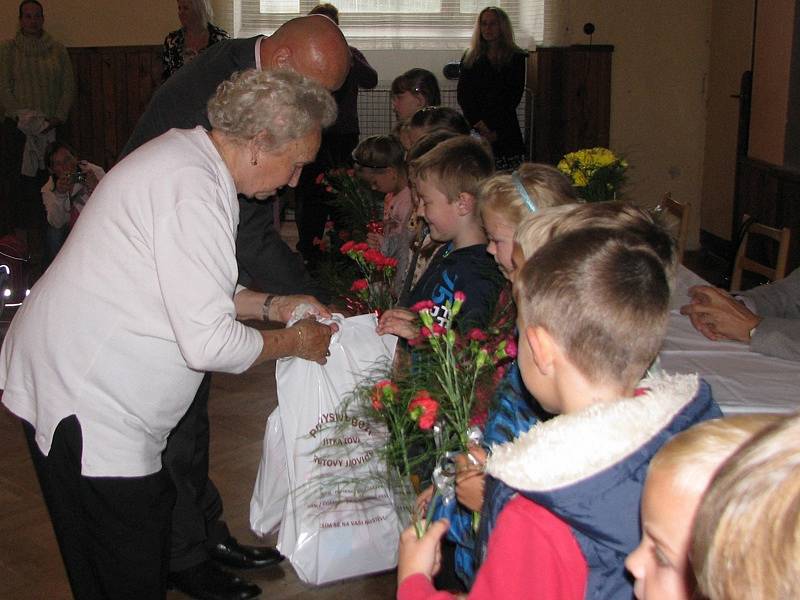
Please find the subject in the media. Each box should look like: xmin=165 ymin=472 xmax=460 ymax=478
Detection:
xmin=458 ymin=6 xmax=527 ymax=171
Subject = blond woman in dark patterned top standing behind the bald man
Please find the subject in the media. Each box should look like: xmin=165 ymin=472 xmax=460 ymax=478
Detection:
xmin=161 ymin=0 xmax=229 ymax=81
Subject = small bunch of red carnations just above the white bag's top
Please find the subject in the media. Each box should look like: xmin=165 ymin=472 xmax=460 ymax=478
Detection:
xmin=339 ymin=240 xmax=397 ymax=316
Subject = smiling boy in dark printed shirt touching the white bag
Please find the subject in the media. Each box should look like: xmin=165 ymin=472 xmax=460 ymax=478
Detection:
xmin=378 ymin=135 xmax=501 ymax=339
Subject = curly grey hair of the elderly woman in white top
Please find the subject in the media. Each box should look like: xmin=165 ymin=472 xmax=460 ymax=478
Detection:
xmin=208 ymin=69 xmax=336 ymax=151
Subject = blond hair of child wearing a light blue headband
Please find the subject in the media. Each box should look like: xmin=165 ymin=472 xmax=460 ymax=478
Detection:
xmin=479 ymin=163 xmax=578 ymax=223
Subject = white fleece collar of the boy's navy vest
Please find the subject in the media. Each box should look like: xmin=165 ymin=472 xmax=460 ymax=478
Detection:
xmin=486 ymin=374 xmax=699 ymax=491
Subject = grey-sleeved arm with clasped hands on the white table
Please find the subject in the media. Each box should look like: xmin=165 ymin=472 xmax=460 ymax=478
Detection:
xmin=681 ymin=269 xmax=800 ymax=361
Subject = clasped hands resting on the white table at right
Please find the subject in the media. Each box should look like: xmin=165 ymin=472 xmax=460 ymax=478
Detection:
xmin=681 ymin=285 xmax=761 ymax=343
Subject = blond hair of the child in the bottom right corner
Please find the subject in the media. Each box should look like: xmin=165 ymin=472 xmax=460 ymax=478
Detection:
xmin=689 ymin=415 xmax=800 ymax=600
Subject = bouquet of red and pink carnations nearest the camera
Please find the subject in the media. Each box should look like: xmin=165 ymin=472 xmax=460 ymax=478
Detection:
xmin=334 ymin=292 xmax=516 ymax=535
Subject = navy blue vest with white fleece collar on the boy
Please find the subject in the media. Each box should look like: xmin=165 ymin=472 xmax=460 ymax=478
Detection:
xmin=487 ymin=375 xmax=722 ymax=600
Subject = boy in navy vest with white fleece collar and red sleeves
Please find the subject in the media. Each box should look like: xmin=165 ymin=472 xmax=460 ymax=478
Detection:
xmin=397 ymin=218 xmax=721 ymax=600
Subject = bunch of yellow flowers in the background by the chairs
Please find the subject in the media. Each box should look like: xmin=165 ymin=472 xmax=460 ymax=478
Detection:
xmin=558 ymin=148 xmax=628 ymax=202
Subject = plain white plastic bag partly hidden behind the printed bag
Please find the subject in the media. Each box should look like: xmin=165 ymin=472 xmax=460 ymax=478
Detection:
xmin=250 ymin=406 xmax=289 ymax=535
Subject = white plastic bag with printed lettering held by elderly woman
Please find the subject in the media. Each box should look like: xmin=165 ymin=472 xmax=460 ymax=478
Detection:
xmin=268 ymin=314 xmax=400 ymax=584
